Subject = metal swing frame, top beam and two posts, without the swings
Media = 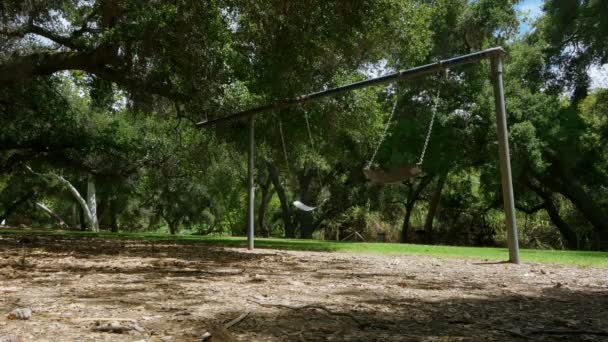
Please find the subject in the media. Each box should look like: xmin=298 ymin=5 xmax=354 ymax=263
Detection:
xmin=196 ymin=47 xmax=519 ymax=264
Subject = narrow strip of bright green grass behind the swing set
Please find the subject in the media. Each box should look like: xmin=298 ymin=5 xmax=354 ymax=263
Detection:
xmin=0 ymin=229 xmax=608 ymax=268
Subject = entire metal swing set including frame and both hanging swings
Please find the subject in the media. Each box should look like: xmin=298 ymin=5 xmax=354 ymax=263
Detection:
xmin=196 ymin=47 xmax=519 ymax=264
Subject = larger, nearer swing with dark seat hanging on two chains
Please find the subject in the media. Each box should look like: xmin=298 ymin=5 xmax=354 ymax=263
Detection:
xmin=363 ymin=92 xmax=439 ymax=184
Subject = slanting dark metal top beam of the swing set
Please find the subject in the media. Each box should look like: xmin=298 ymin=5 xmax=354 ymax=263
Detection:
xmin=196 ymin=47 xmax=505 ymax=127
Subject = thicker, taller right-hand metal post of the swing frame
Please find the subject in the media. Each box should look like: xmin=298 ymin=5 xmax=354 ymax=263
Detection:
xmin=492 ymin=53 xmax=519 ymax=264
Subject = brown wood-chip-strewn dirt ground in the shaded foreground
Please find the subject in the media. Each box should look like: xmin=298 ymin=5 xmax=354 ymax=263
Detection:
xmin=0 ymin=237 xmax=608 ymax=341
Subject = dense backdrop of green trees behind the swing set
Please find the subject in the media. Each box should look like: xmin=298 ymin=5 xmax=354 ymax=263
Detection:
xmin=0 ymin=0 xmax=608 ymax=248
